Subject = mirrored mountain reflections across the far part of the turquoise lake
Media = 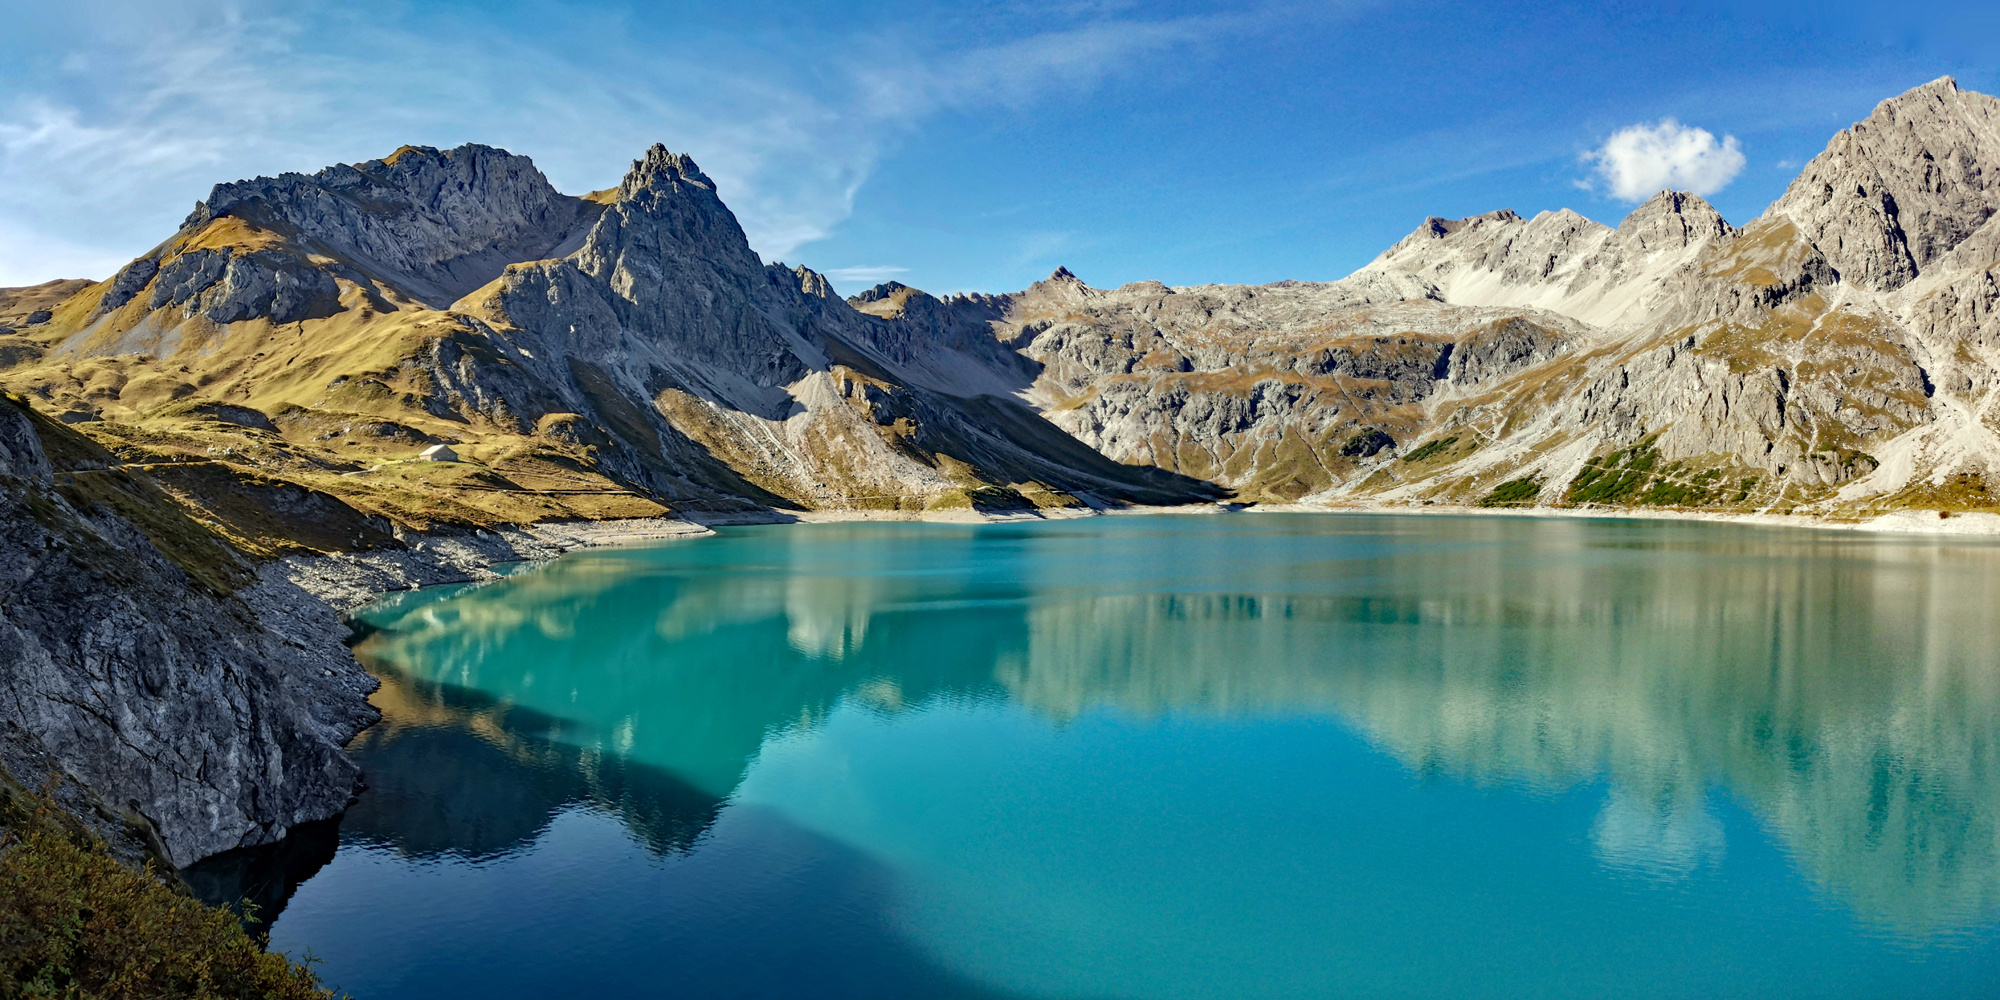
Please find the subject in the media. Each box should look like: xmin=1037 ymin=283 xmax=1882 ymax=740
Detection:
xmin=258 ymin=516 xmax=2000 ymax=996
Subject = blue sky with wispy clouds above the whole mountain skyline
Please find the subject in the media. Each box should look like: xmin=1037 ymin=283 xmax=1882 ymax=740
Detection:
xmin=0 ymin=0 xmax=2000 ymax=294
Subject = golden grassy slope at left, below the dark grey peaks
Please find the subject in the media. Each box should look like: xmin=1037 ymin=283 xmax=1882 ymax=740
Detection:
xmin=0 ymin=286 xmax=666 ymax=536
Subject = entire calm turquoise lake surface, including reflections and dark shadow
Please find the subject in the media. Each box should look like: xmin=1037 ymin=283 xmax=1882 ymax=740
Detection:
xmin=266 ymin=514 xmax=2000 ymax=1000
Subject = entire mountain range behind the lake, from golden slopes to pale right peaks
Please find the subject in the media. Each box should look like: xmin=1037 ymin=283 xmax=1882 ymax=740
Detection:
xmin=0 ymin=78 xmax=2000 ymax=526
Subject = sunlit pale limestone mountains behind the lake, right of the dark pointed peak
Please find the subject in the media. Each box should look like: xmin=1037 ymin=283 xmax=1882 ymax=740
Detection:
xmin=856 ymin=80 xmax=2000 ymax=512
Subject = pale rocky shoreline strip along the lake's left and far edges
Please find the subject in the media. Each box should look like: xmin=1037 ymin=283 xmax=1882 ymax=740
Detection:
xmin=11 ymin=482 xmax=2000 ymax=884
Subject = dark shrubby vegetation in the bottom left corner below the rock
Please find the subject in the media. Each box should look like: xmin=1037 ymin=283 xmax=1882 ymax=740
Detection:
xmin=0 ymin=808 xmax=330 ymax=1000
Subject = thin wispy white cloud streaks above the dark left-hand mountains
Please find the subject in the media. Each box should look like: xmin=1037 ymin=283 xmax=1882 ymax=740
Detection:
xmin=0 ymin=0 xmax=1256 ymax=284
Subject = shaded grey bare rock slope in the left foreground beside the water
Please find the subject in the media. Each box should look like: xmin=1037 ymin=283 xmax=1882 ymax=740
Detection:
xmin=0 ymin=400 xmax=374 ymax=864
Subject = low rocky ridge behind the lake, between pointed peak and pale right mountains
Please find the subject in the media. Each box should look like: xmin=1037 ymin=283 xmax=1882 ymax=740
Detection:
xmin=856 ymin=270 xmax=1586 ymax=498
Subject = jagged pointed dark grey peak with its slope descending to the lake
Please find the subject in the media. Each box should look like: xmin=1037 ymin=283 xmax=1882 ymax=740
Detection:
xmin=442 ymin=146 xmax=1204 ymax=506
